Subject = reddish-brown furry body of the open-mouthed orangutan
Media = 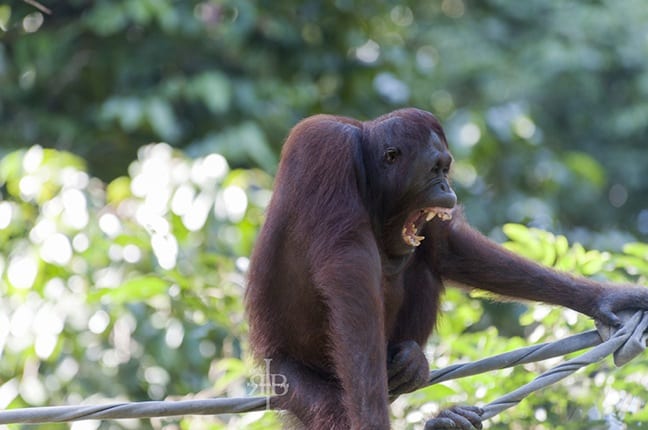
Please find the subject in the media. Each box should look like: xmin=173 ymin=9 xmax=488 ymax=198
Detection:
xmin=246 ymin=109 xmax=648 ymax=429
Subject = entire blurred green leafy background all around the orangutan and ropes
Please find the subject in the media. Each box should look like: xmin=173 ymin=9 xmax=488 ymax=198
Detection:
xmin=0 ymin=0 xmax=648 ymax=429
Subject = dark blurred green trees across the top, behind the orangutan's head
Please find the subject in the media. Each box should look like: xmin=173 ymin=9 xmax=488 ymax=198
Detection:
xmin=0 ymin=0 xmax=648 ymax=240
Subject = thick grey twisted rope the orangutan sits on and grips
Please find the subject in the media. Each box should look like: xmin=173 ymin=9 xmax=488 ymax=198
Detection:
xmin=0 ymin=311 xmax=648 ymax=424
